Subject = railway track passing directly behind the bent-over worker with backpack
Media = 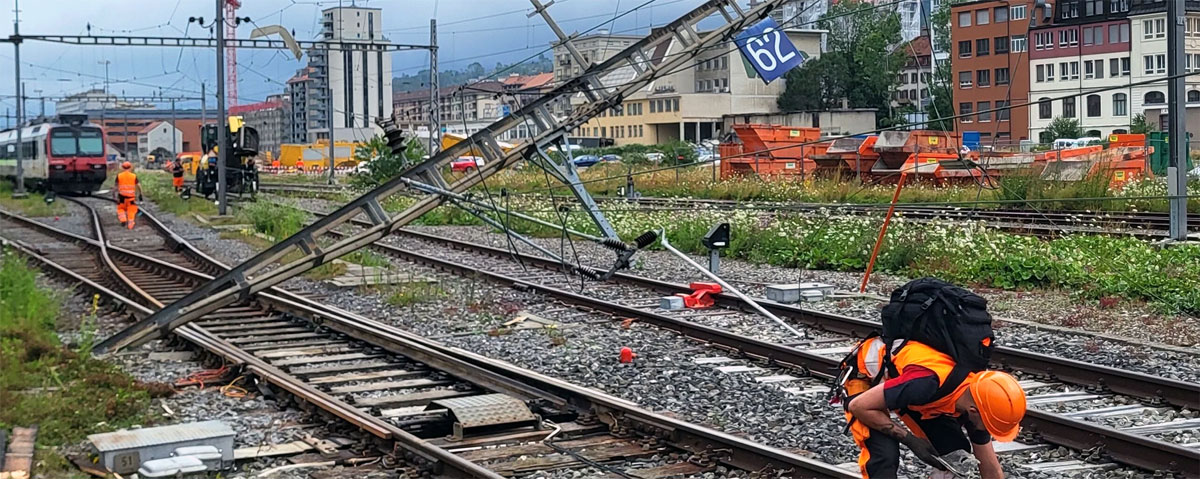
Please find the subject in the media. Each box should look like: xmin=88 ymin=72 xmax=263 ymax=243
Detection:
xmin=312 ymin=216 xmax=1200 ymax=477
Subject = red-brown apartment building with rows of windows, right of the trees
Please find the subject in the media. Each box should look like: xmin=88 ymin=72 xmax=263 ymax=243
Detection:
xmin=940 ymin=0 xmax=1034 ymax=148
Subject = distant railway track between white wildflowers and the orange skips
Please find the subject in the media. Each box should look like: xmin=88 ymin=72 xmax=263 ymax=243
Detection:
xmin=520 ymin=197 xmax=1185 ymax=239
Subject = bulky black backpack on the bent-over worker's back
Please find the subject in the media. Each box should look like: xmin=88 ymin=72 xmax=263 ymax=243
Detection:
xmin=881 ymin=277 xmax=996 ymax=397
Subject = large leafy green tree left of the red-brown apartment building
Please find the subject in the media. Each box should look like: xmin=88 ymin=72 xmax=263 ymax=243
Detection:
xmin=778 ymin=0 xmax=907 ymax=126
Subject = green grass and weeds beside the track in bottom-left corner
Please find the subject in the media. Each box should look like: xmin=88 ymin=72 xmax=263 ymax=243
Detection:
xmin=0 ymin=252 xmax=159 ymax=477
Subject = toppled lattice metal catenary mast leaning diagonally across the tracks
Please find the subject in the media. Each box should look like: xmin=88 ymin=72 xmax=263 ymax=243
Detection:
xmin=94 ymin=0 xmax=785 ymax=354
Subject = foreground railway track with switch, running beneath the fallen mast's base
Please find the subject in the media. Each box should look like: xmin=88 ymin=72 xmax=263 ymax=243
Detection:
xmin=0 ymin=198 xmax=857 ymax=479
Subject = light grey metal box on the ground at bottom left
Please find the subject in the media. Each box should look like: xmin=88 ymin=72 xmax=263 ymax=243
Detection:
xmin=88 ymin=421 xmax=235 ymax=474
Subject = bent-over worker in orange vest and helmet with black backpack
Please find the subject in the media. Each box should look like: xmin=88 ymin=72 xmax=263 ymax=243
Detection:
xmin=834 ymin=279 xmax=1026 ymax=479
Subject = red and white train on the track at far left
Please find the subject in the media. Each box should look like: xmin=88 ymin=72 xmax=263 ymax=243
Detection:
xmin=0 ymin=115 xmax=108 ymax=193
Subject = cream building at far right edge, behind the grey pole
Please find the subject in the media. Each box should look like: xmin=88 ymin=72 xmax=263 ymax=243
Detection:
xmin=1129 ymin=0 xmax=1200 ymax=138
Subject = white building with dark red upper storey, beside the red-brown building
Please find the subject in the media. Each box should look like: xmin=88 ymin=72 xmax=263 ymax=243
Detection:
xmin=1025 ymin=0 xmax=1136 ymax=143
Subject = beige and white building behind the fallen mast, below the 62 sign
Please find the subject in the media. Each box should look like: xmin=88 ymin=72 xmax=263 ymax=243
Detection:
xmin=571 ymin=30 xmax=824 ymax=145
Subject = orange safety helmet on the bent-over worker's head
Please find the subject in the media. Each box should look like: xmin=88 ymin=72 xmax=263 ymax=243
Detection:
xmin=970 ymin=371 xmax=1025 ymax=442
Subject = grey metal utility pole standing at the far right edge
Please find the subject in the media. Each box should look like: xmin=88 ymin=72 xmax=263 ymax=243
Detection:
xmin=1166 ymin=0 xmax=1188 ymax=241
